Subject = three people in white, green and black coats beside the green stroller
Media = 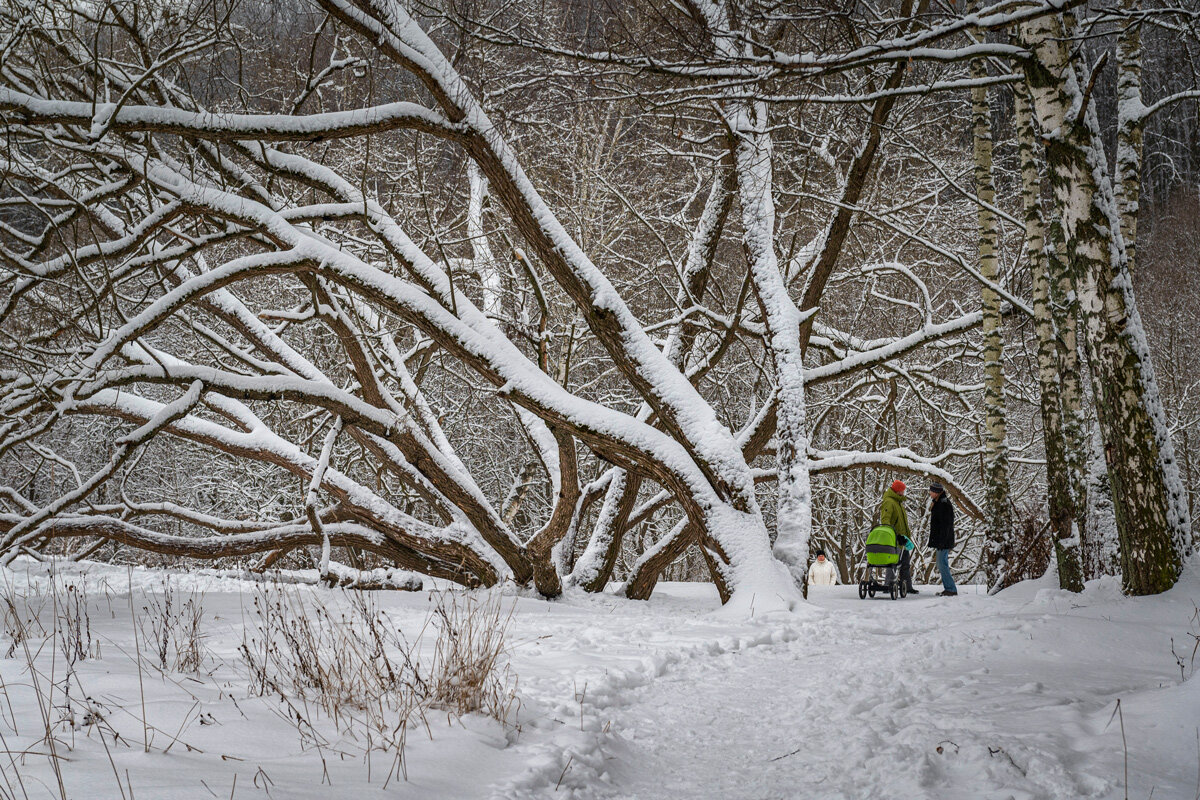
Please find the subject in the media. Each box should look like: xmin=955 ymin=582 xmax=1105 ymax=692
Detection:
xmin=809 ymin=481 xmax=959 ymax=597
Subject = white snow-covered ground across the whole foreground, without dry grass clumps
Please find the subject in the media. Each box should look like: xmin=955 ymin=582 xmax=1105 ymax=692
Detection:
xmin=0 ymin=563 xmax=1200 ymax=800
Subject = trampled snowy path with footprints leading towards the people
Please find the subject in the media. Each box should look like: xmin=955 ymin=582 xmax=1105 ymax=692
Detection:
xmin=600 ymin=588 xmax=1098 ymax=800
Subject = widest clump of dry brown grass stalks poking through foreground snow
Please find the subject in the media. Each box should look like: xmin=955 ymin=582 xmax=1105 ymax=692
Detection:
xmin=240 ymin=587 xmax=517 ymax=780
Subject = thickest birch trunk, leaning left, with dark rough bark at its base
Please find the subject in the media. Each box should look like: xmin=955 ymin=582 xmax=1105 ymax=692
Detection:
xmin=1020 ymin=10 xmax=1190 ymax=595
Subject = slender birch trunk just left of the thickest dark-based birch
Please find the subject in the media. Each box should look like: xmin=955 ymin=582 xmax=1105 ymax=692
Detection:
xmin=1013 ymin=84 xmax=1084 ymax=591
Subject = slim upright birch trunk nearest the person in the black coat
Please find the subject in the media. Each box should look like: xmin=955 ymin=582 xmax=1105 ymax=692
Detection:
xmin=971 ymin=48 xmax=1013 ymax=590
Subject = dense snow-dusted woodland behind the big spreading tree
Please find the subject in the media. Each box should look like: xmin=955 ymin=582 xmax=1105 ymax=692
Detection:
xmin=0 ymin=0 xmax=1200 ymax=599
